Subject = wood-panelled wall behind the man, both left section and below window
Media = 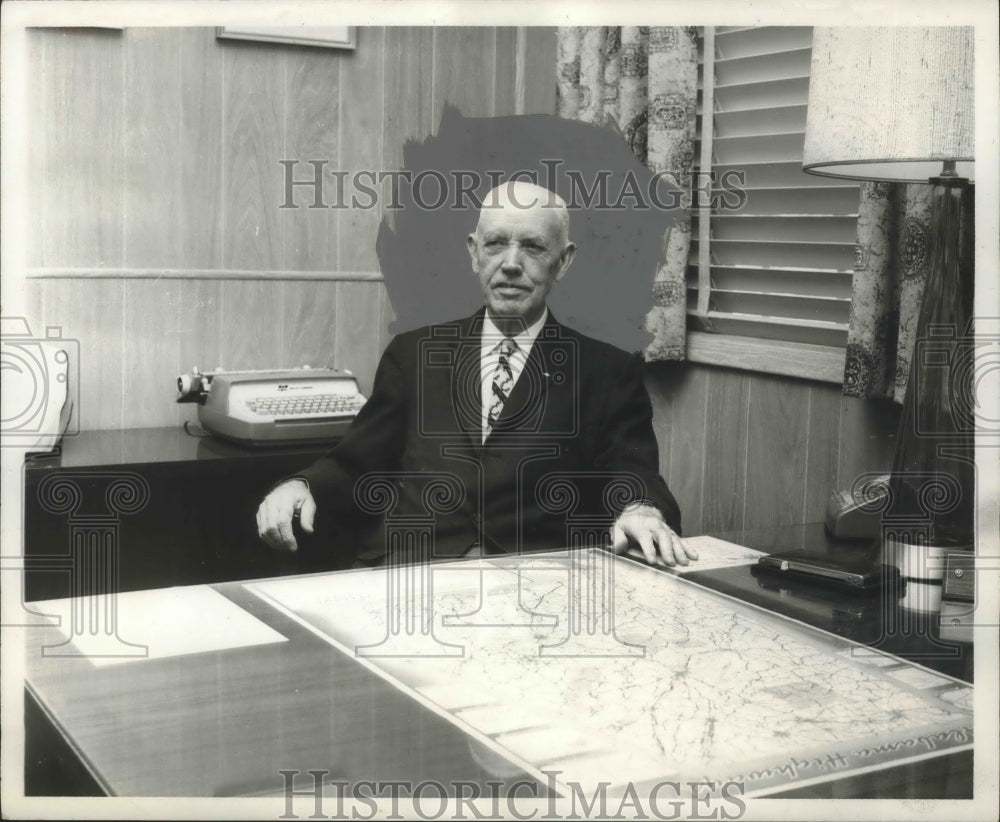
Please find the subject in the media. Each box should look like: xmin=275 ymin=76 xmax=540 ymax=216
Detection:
xmin=28 ymin=28 xmax=897 ymax=534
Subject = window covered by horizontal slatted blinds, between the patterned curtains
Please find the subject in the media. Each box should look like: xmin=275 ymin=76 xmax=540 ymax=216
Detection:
xmin=688 ymin=26 xmax=858 ymax=382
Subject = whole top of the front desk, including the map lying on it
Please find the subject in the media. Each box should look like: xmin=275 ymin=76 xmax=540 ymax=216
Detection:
xmin=28 ymin=536 xmax=972 ymax=796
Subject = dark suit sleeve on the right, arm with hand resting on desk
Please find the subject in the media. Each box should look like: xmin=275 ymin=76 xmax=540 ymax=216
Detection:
xmin=595 ymin=355 xmax=681 ymax=534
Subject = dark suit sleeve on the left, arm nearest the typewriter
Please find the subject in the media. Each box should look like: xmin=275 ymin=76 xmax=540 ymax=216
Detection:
xmin=297 ymin=338 xmax=407 ymax=518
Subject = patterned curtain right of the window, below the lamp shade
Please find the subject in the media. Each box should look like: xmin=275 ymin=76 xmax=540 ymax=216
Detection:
xmin=844 ymin=182 xmax=974 ymax=403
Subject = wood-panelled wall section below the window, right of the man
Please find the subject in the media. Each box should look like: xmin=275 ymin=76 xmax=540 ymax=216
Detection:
xmin=646 ymin=363 xmax=899 ymax=534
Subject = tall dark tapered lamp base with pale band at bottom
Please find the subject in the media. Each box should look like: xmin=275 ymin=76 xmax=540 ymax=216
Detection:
xmin=882 ymin=174 xmax=976 ymax=611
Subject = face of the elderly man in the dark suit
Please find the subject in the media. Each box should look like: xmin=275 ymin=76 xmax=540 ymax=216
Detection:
xmin=468 ymin=203 xmax=576 ymax=326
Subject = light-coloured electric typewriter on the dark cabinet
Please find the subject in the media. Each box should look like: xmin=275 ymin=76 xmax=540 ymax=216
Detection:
xmin=177 ymin=366 xmax=365 ymax=446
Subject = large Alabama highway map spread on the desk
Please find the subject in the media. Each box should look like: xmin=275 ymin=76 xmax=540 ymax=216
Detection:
xmin=248 ymin=551 xmax=972 ymax=795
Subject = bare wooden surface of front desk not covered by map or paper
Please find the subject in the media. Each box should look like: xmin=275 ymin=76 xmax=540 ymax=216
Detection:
xmin=27 ymin=536 xmax=971 ymax=798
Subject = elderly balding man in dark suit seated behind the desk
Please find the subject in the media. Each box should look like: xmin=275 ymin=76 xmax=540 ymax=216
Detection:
xmin=257 ymin=182 xmax=696 ymax=565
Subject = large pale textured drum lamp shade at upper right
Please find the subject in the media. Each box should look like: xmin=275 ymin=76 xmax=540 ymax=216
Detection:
xmin=802 ymin=26 xmax=975 ymax=182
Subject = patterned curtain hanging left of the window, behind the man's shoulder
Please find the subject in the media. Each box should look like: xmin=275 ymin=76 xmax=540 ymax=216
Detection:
xmin=557 ymin=26 xmax=698 ymax=360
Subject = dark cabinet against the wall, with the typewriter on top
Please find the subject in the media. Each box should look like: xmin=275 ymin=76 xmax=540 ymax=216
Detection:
xmin=24 ymin=427 xmax=338 ymax=602
